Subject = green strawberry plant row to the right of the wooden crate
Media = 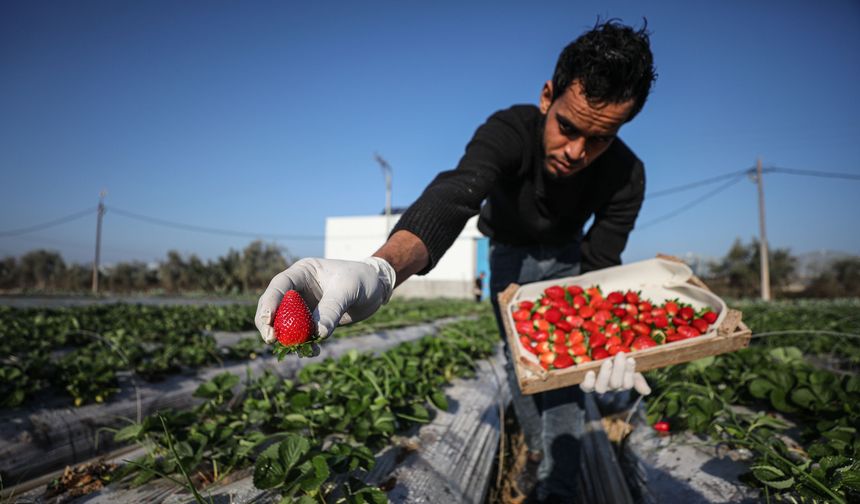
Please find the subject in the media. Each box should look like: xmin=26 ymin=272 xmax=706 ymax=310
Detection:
xmin=647 ymin=301 xmax=860 ymax=502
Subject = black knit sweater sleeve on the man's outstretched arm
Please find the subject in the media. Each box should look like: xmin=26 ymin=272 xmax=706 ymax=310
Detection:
xmin=392 ymin=111 xmax=524 ymax=275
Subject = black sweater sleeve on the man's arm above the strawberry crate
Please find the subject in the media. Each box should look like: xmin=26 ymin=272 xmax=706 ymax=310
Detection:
xmin=582 ymin=161 xmax=645 ymax=273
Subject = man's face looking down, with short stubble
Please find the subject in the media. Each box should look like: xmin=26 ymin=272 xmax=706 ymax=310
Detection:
xmin=540 ymin=81 xmax=633 ymax=178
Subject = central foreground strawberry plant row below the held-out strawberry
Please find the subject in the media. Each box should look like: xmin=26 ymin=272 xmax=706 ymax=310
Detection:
xmin=88 ymin=314 xmax=499 ymax=503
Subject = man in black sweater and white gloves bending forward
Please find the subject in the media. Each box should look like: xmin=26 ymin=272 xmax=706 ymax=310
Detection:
xmin=256 ymin=21 xmax=655 ymax=502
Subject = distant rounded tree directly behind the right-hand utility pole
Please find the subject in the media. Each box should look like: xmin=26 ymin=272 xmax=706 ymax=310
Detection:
xmin=708 ymin=238 xmax=797 ymax=297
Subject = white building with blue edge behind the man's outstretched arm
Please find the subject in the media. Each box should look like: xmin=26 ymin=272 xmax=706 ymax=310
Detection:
xmin=325 ymin=215 xmax=490 ymax=299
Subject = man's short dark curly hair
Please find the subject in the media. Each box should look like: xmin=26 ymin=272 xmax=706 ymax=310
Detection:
xmin=552 ymin=19 xmax=657 ymax=121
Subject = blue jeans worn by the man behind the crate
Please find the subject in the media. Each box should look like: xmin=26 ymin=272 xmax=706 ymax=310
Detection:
xmin=490 ymin=242 xmax=585 ymax=499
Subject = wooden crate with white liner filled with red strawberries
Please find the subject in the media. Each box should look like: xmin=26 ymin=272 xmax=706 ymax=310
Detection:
xmin=499 ymin=256 xmax=751 ymax=394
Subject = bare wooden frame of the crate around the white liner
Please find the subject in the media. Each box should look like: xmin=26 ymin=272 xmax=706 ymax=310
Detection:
xmin=498 ymin=254 xmax=752 ymax=394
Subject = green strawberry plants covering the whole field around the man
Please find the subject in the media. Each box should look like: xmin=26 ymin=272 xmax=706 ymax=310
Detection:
xmin=0 ymin=300 xmax=860 ymax=503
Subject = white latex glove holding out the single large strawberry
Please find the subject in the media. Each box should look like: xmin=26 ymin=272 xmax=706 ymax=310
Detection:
xmin=254 ymin=257 xmax=396 ymax=343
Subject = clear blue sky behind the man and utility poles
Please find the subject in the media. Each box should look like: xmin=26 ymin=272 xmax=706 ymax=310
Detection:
xmin=0 ymin=0 xmax=860 ymax=262
